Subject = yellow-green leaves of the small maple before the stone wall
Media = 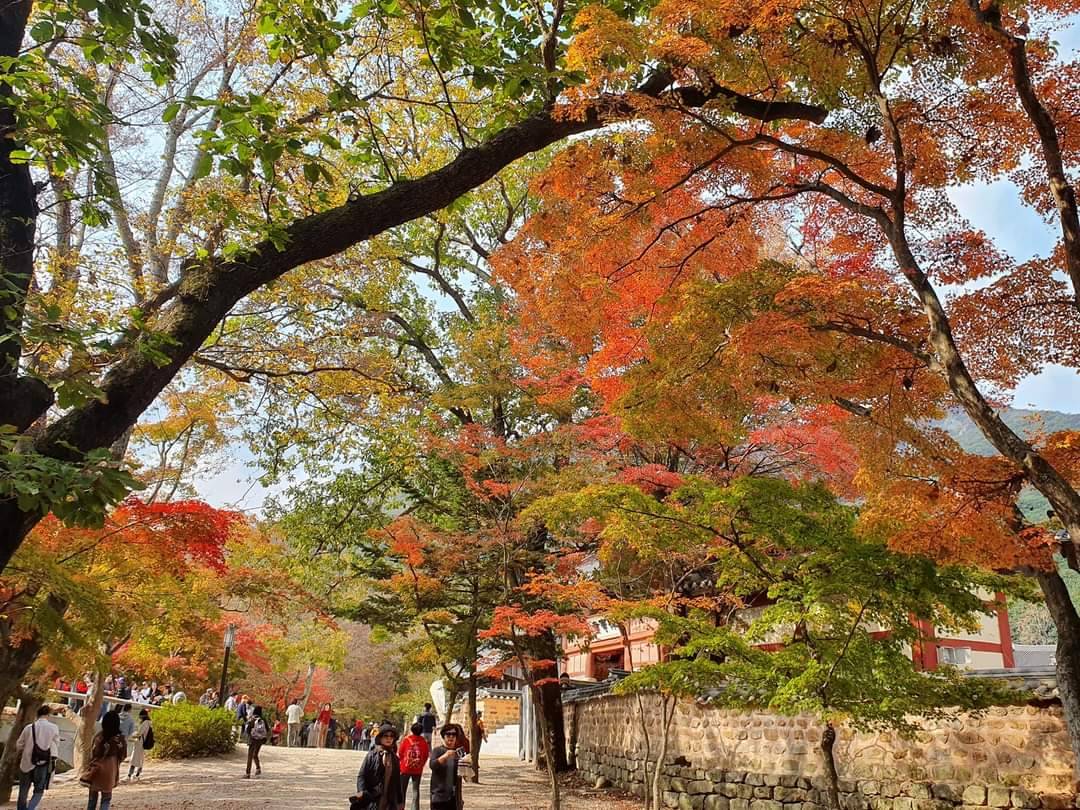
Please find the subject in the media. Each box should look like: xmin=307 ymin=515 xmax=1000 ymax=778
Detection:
xmin=548 ymin=477 xmax=1028 ymax=731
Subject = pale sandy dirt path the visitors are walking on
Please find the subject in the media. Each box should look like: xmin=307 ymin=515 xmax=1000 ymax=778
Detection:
xmin=41 ymin=746 xmax=638 ymax=810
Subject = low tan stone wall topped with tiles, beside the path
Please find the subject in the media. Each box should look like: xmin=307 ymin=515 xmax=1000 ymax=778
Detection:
xmin=565 ymin=696 xmax=1076 ymax=810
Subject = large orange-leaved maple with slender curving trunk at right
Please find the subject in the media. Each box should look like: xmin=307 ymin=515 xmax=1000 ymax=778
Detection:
xmin=496 ymin=2 xmax=1080 ymax=773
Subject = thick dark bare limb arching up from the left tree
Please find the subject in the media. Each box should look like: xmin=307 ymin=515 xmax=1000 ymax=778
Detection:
xmin=0 ymin=72 xmax=827 ymax=570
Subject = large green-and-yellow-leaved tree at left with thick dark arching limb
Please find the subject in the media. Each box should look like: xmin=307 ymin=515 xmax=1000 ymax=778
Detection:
xmin=0 ymin=0 xmax=824 ymax=578
